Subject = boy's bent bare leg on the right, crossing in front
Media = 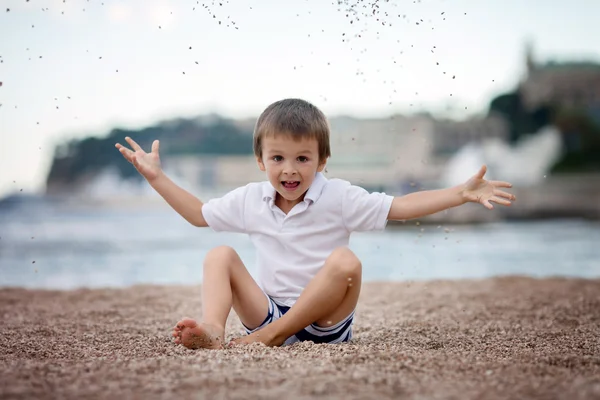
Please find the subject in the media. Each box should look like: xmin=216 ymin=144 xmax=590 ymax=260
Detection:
xmin=235 ymin=247 xmax=362 ymax=346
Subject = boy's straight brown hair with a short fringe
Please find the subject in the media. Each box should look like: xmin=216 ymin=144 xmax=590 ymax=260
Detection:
xmin=254 ymin=99 xmax=331 ymax=163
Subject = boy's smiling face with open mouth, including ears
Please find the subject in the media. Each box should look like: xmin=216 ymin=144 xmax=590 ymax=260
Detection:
xmin=258 ymin=134 xmax=325 ymax=209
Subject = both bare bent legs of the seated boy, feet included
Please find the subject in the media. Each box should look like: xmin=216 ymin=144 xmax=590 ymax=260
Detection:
xmin=173 ymin=246 xmax=362 ymax=349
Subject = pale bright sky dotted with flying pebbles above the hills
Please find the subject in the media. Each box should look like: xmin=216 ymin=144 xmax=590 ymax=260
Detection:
xmin=0 ymin=0 xmax=600 ymax=198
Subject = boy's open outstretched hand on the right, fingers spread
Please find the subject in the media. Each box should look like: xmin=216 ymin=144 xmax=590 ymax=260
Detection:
xmin=462 ymin=165 xmax=516 ymax=210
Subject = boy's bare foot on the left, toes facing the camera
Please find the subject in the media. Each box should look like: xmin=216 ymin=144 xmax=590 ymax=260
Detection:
xmin=173 ymin=318 xmax=223 ymax=349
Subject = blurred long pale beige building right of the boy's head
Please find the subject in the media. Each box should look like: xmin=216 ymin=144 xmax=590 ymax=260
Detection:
xmin=327 ymin=115 xmax=509 ymax=190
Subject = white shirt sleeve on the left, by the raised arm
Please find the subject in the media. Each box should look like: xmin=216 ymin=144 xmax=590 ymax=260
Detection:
xmin=202 ymin=186 xmax=248 ymax=233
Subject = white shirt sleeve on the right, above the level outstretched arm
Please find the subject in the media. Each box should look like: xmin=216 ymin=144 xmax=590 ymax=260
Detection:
xmin=342 ymin=185 xmax=394 ymax=232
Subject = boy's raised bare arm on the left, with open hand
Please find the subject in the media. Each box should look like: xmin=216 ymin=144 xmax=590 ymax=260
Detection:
xmin=115 ymin=137 xmax=208 ymax=227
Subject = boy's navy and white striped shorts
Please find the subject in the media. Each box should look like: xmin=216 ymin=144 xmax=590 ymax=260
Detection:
xmin=244 ymin=296 xmax=354 ymax=346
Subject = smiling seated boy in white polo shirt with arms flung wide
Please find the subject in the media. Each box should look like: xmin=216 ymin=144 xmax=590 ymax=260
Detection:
xmin=116 ymin=99 xmax=515 ymax=349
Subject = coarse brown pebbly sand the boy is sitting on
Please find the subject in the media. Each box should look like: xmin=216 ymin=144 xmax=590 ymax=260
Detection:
xmin=0 ymin=277 xmax=600 ymax=400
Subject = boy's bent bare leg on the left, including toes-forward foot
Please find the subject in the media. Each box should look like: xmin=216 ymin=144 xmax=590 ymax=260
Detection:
xmin=173 ymin=246 xmax=269 ymax=348
